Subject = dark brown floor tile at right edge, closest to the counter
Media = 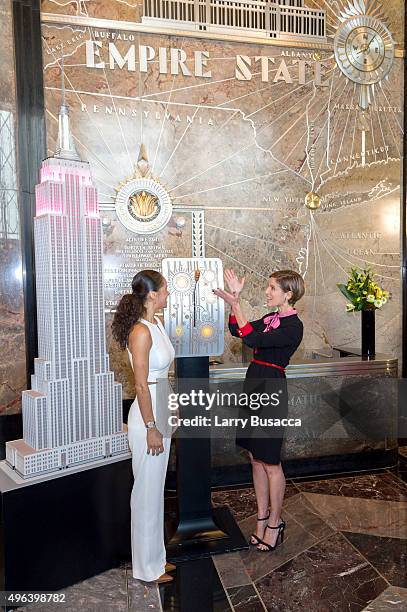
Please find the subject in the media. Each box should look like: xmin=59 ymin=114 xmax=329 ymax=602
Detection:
xmin=296 ymin=472 xmax=407 ymax=501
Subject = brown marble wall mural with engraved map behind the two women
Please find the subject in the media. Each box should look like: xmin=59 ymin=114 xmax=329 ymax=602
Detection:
xmin=42 ymin=0 xmax=404 ymax=397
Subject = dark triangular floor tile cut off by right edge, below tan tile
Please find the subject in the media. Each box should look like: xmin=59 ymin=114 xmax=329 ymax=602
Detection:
xmin=344 ymin=532 xmax=407 ymax=587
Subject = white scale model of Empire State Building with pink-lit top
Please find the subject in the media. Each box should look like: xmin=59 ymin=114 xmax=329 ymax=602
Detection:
xmin=6 ymin=100 xmax=129 ymax=478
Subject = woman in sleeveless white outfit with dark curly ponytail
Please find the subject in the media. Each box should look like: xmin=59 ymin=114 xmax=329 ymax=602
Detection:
xmin=112 ymin=270 xmax=175 ymax=582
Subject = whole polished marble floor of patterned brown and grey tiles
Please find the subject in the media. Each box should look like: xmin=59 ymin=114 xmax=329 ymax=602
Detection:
xmin=21 ymin=447 xmax=407 ymax=612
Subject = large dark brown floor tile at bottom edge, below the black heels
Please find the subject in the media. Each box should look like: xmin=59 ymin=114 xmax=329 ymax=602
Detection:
xmin=256 ymin=534 xmax=388 ymax=612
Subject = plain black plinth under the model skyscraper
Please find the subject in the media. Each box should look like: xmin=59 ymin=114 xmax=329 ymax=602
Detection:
xmin=0 ymin=459 xmax=133 ymax=592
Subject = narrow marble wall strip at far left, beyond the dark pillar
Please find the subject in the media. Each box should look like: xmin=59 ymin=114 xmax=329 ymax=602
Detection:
xmin=0 ymin=0 xmax=26 ymax=415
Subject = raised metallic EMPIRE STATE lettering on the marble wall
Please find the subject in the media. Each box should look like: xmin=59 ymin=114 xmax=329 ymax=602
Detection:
xmin=86 ymin=40 xmax=327 ymax=87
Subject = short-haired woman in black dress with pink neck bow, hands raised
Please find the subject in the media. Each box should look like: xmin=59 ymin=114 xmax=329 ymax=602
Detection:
xmin=214 ymin=270 xmax=305 ymax=551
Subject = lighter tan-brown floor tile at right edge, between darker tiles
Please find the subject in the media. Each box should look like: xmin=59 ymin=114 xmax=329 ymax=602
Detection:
xmin=304 ymin=493 xmax=407 ymax=538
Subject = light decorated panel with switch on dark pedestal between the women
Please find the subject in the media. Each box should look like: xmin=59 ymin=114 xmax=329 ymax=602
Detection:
xmin=163 ymin=258 xmax=248 ymax=562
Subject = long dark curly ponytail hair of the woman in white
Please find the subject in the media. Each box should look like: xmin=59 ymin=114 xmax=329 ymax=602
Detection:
xmin=112 ymin=270 xmax=164 ymax=349
